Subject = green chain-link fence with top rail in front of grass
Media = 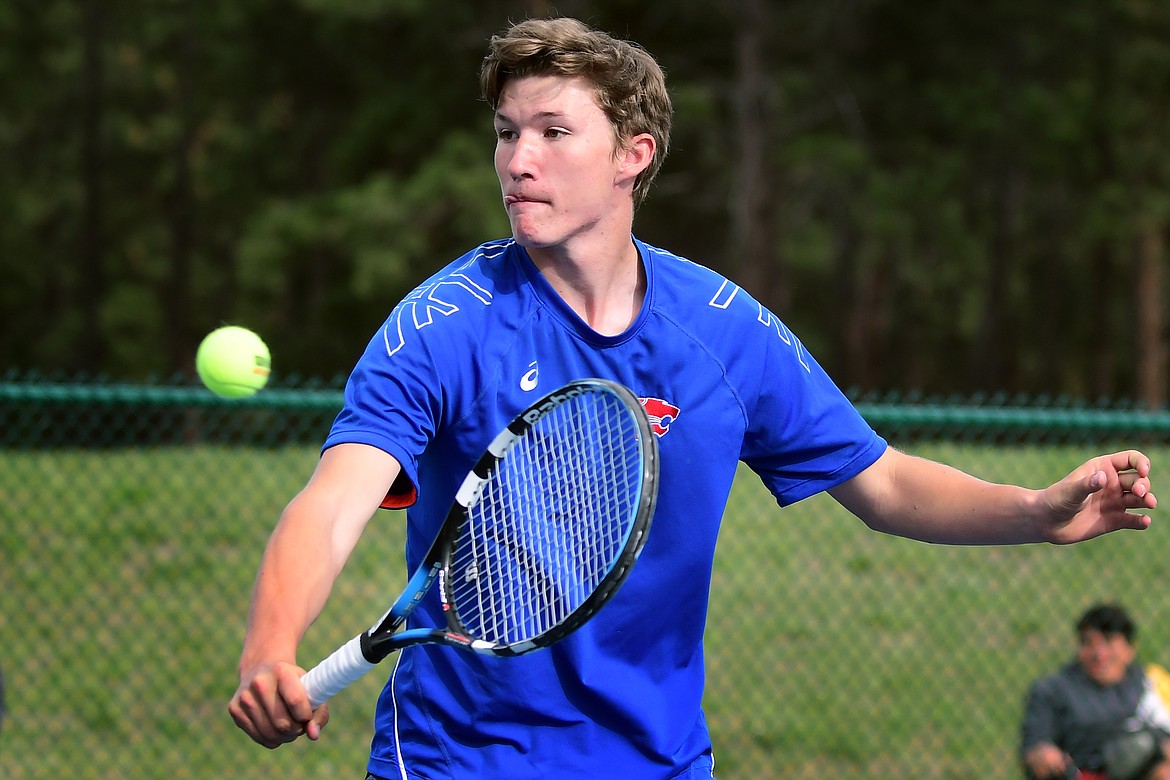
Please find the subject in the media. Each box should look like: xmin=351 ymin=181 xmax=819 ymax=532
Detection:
xmin=0 ymin=375 xmax=1170 ymax=780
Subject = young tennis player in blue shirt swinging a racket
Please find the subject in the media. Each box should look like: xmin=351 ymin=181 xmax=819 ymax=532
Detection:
xmin=229 ymin=19 xmax=1156 ymax=780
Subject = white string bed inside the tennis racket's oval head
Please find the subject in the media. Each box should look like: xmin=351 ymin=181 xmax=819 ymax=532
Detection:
xmin=452 ymin=393 xmax=644 ymax=644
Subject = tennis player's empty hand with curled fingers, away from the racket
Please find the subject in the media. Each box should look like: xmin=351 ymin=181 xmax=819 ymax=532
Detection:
xmin=1044 ymin=450 xmax=1158 ymax=544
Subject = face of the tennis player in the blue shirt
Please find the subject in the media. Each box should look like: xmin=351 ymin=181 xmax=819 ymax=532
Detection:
xmin=495 ymin=76 xmax=653 ymax=249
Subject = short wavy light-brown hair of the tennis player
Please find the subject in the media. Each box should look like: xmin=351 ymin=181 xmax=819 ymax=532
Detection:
xmin=480 ymin=18 xmax=673 ymax=207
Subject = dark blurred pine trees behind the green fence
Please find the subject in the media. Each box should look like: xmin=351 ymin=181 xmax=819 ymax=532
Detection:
xmin=0 ymin=0 xmax=1170 ymax=406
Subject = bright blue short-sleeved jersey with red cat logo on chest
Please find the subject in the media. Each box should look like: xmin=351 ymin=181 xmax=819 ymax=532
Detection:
xmin=325 ymin=240 xmax=886 ymax=780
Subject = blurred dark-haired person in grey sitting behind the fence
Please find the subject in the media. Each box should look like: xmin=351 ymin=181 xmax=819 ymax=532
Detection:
xmin=1020 ymin=603 xmax=1170 ymax=780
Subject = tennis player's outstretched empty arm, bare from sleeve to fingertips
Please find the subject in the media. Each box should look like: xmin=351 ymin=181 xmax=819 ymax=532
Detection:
xmin=830 ymin=448 xmax=1157 ymax=545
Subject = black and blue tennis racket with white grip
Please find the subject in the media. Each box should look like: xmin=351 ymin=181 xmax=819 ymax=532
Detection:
xmin=301 ymin=379 xmax=659 ymax=709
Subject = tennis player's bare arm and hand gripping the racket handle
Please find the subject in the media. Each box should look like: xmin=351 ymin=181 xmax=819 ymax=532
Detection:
xmin=228 ymin=444 xmax=401 ymax=748
